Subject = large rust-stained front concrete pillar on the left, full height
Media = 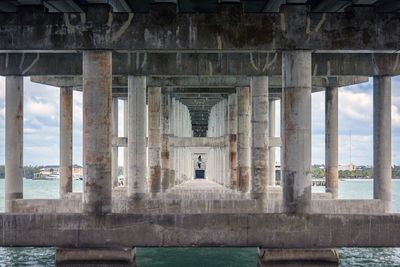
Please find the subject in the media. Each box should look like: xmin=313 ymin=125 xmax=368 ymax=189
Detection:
xmin=83 ymin=51 xmax=112 ymax=214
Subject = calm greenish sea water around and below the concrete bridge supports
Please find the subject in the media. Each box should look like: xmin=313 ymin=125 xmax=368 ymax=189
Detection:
xmin=0 ymin=179 xmax=400 ymax=267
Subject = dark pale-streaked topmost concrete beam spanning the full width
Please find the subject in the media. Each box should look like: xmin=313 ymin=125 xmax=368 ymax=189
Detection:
xmin=0 ymin=5 xmax=400 ymax=52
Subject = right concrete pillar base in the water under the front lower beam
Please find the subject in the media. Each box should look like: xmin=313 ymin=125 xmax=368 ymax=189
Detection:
xmin=258 ymin=248 xmax=339 ymax=267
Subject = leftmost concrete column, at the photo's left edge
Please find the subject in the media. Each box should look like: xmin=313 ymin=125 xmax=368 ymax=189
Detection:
xmin=5 ymin=76 xmax=24 ymax=212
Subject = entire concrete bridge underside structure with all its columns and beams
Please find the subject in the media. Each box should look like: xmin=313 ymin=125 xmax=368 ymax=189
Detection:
xmin=0 ymin=0 xmax=400 ymax=266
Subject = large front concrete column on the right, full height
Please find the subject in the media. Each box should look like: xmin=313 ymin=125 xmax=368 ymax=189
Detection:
xmin=281 ymin=50 xmax=311 ymax=213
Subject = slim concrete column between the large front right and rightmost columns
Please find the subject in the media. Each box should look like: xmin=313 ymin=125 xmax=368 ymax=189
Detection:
xmin=325 ymin=87 xmax=339 ymax=198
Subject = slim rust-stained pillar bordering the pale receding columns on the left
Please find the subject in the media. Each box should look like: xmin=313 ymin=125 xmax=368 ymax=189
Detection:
xmin=161 ymin=93 xmax=170 ymax=192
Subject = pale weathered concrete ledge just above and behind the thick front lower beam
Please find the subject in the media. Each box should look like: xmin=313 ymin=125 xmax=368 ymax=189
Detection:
xmin=10 ymin=197 xmax=385 ymax=214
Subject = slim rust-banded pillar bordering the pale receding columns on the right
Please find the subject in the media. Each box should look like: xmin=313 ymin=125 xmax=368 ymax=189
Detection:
xmin=228 ymin=94 xmax=238 ymax=189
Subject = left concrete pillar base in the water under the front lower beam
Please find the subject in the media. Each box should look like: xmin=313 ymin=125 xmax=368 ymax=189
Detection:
xmin=56 ymin=248 xmax=136 ymax=267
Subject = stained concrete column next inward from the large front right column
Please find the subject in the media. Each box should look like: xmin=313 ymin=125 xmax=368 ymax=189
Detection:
xmin=251 ymin=76 xmax=269 ymax=199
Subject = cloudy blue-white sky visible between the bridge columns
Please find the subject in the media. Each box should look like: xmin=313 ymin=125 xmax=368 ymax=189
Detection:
xmin=0 ymin=76 xmax=400 ymax=168
